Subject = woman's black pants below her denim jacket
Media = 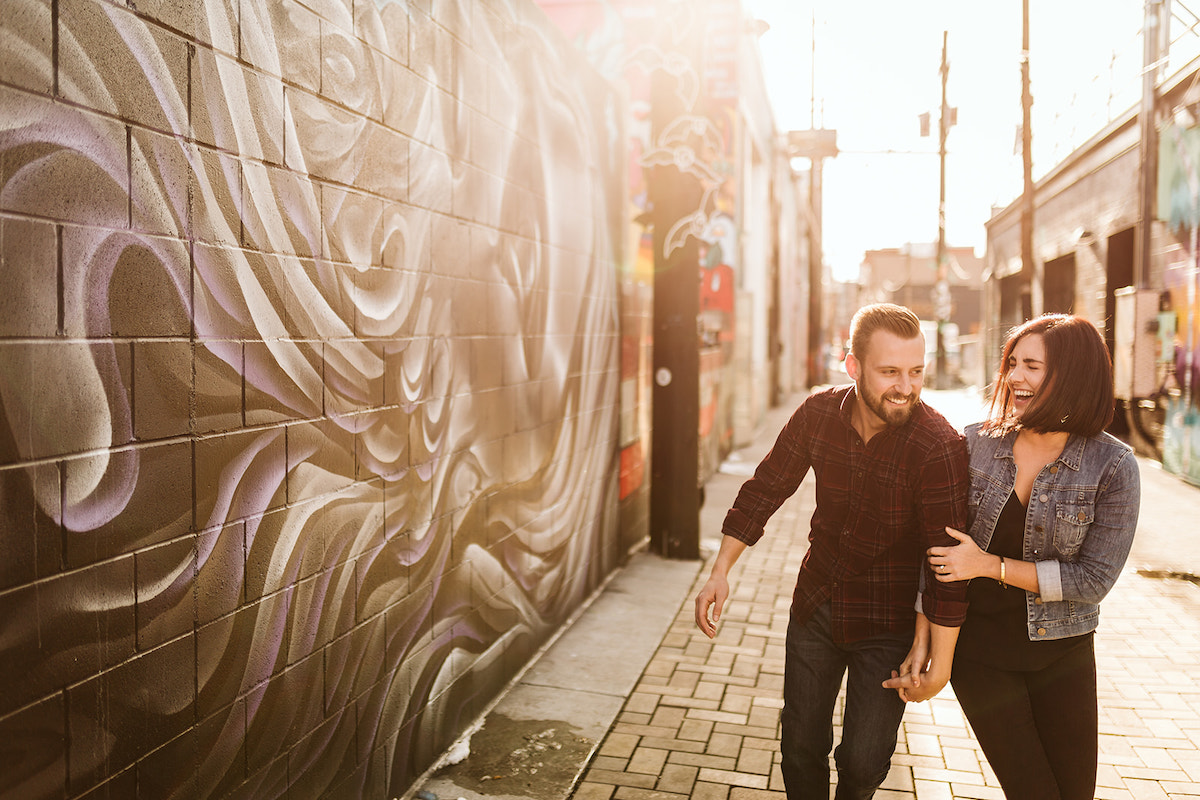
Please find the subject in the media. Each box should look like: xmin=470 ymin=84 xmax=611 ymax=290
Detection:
xmin=950 ymin=636 xmax=1098 ymax=800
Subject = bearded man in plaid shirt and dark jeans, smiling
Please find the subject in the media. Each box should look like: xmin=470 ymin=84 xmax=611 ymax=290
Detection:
xmin=696 ymin=303 xmax=967 ymax=800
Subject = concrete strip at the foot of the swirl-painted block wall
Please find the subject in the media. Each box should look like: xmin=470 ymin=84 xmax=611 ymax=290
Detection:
xmin=414 ymin=552 xmax=701 ymax=800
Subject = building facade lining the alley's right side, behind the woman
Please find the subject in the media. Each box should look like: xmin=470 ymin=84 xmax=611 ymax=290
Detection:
xmin=985 ymin=54 xmax=1200 ymax=482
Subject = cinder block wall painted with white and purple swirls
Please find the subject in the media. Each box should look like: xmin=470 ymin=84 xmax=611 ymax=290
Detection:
xmin=0 ymin=0 xmax=628 ymax=798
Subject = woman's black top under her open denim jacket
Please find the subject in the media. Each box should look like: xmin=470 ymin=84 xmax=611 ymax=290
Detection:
xmin=955 ymin=492 xmax=1092 ymax=672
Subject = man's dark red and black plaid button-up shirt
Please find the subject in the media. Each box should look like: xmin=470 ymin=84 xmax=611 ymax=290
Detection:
xmin=722 ymin=385 xmax=970 ymax=643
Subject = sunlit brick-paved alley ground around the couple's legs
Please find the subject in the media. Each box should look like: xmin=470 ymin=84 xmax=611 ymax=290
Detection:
xmin=574 ymin=474 xmax=1200 ymax=800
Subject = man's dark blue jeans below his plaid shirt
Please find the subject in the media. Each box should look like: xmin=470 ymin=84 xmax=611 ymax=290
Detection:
xmin=781 ymin=603 xmax=912 ymax=800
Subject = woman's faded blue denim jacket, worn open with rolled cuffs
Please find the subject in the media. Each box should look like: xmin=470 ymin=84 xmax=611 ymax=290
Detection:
xmin=965 ymin=423 xmax=1141 ymax=642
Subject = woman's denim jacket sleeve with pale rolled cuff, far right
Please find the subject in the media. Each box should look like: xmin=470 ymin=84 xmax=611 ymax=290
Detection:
xmin=1037 ymin=452 xmax=1141 ymax=603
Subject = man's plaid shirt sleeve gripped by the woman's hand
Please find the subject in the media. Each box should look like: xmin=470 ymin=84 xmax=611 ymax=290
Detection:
xmin=917 ymin=437 xmax=971 ymax=627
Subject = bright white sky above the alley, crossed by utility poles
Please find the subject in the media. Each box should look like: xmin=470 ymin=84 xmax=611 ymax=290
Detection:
xmin=743 ymin=0 xmax=1166 ymax=281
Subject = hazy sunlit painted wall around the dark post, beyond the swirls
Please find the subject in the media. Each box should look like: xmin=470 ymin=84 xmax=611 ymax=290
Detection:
xmin=538 ymin=0 xmax=743 ymax=499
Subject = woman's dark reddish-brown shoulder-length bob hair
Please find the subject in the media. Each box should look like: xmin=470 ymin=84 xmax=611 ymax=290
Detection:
xmin=985 ymin=314 xmax=1114 ymax=437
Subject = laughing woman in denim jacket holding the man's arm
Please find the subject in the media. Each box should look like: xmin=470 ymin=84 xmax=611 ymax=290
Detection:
xmin=901 ymin=314 xmax=1140 ymax=800
